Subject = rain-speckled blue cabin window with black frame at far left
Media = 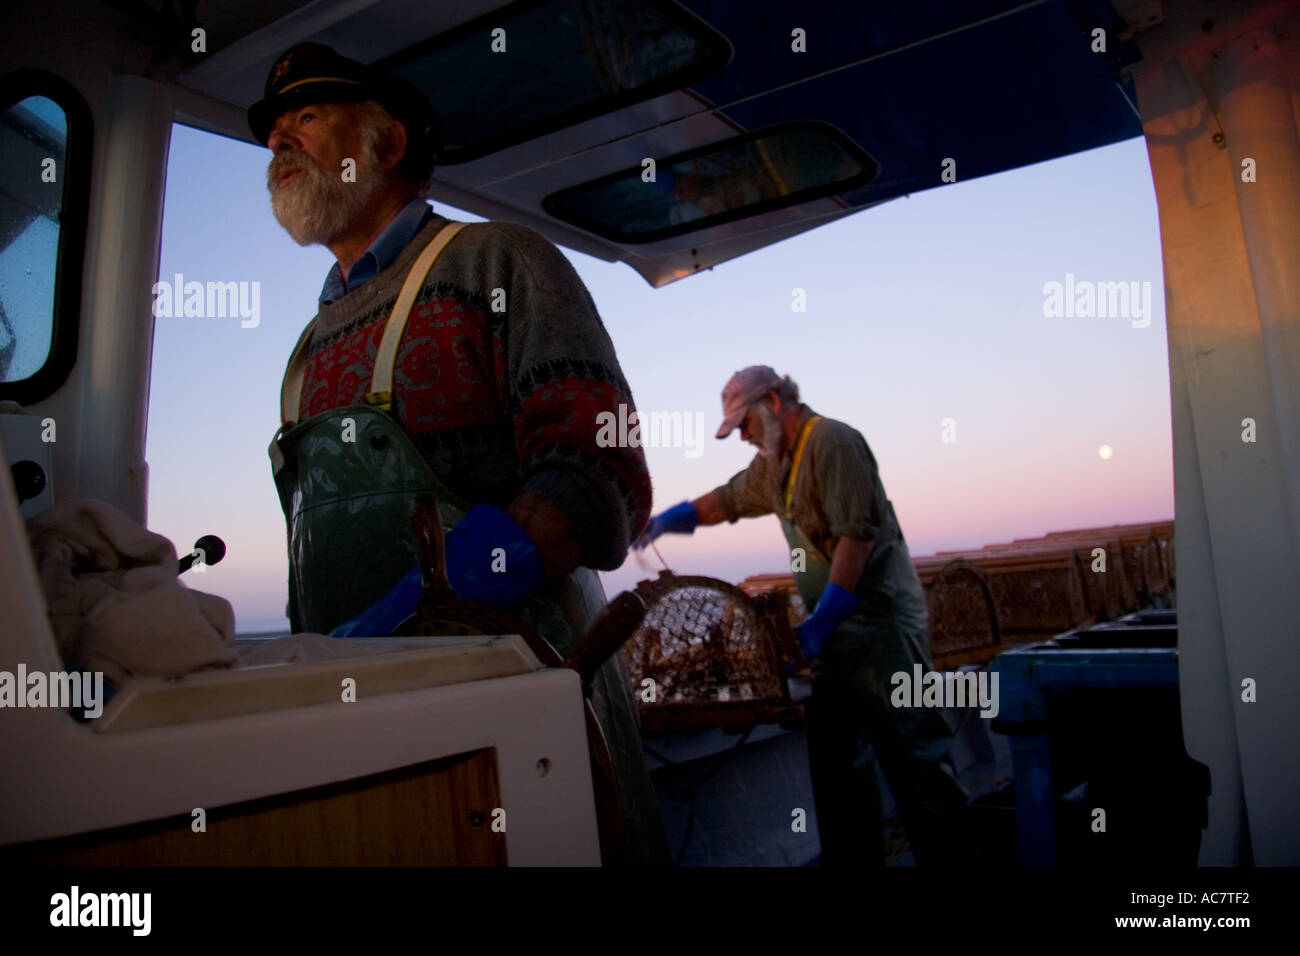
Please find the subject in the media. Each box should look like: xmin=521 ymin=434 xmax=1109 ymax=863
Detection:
xmin=0 ymin=72 xmax=90 ymax=405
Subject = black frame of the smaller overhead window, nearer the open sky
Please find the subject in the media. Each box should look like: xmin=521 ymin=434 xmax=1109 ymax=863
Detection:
xmin=542 ymin=120 xmax=880 ymax=246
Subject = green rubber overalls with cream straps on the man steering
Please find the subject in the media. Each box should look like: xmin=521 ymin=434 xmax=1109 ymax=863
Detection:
xmin=268 ymin=222 xmax=668 ymax=864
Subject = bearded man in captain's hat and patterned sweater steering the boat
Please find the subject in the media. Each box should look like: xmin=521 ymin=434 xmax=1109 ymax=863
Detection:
xmin=256 ymin=43 xmax=668 ymax=864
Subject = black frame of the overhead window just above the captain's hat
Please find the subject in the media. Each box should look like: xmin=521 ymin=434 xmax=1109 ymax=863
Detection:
xmin=372 ymin=0 xmax=736 ymax=166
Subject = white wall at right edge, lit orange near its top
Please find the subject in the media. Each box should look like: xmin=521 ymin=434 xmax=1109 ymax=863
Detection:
xmin=1135 ymin=1 xmax=1300 ymax=866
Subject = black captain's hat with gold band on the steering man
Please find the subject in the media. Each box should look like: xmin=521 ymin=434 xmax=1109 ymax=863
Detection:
xmin=248 ymin=43 xmax=439 ymax=161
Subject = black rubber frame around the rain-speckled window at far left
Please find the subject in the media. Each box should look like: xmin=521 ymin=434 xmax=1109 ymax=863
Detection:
xmin=0 ymin=69 xmax=95 ymax=405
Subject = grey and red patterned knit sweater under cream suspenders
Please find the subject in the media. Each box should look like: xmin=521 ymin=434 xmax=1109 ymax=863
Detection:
xmin=286 ymin=216 xmax=650 ymax=570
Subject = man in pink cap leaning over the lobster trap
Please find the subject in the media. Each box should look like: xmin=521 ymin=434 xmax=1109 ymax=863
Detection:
xmin=633 ymin=365 xmax=966 ymax=865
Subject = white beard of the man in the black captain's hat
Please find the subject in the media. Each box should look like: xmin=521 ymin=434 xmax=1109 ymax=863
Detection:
xmin=267 ymin=147 xmax=384 ymax=246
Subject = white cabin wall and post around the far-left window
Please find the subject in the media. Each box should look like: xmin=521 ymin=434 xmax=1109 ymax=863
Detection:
xmin=0 ymin=3 xmax=180 ymax=523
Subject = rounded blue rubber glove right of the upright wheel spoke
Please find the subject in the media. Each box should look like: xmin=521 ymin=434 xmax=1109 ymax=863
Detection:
xmin=447 ymin=505 xmax=546 ymax=607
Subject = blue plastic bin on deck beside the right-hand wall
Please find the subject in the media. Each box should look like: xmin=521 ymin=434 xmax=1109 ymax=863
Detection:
xmin=991 ymin=611 xmax=1209 ymax=866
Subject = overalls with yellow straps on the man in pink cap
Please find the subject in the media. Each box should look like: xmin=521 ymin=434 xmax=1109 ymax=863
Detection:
xmin=779 ymin=416 xmax=966 ymax=866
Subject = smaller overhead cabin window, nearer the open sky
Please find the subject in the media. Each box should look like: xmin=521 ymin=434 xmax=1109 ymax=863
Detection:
xmin=542 ymin=122 xmax=880 ymax=243
